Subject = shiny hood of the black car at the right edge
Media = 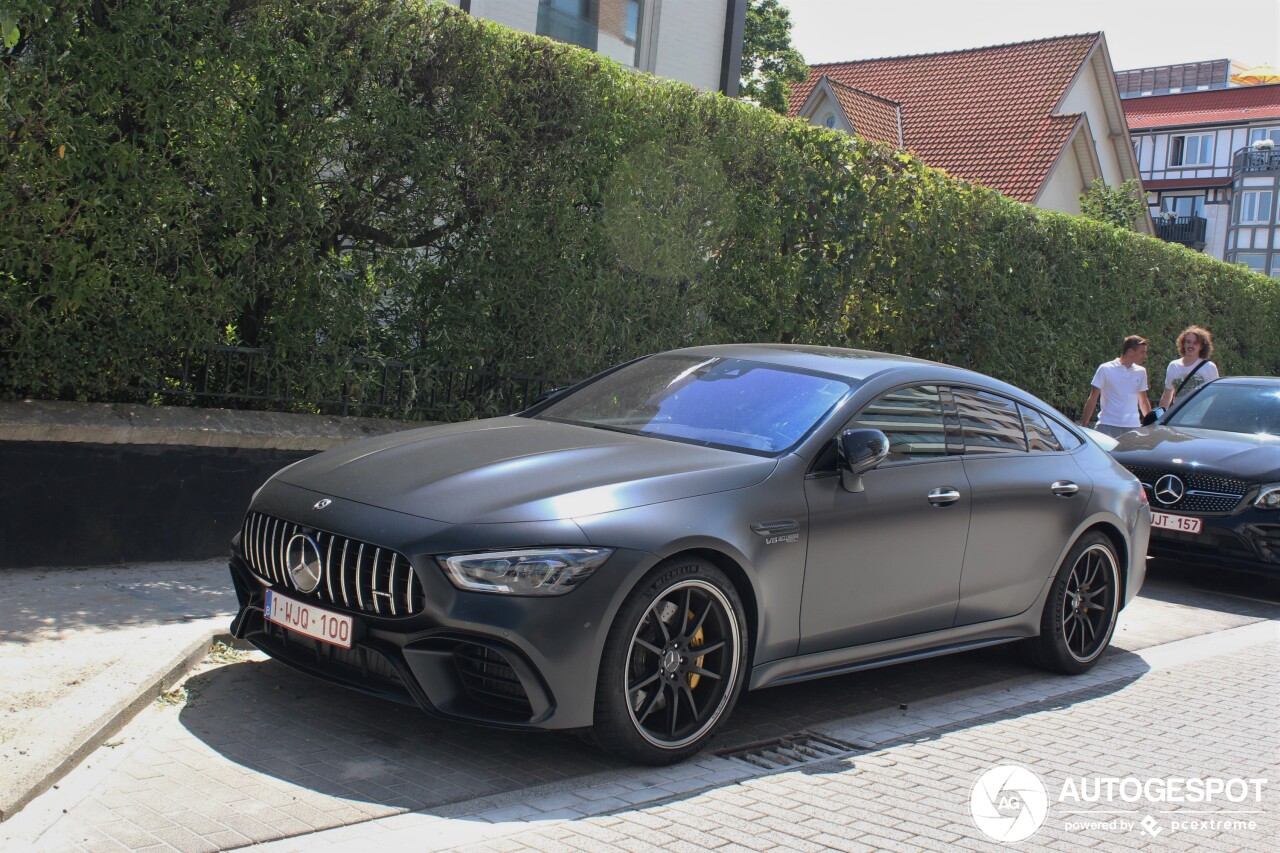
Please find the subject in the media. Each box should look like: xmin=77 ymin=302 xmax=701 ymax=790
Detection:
xmin=1111 ymin=427 xmax=1280 ymax=483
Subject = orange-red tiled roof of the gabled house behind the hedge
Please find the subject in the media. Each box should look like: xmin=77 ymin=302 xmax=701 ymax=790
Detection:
xmin=790 ymin=33 xmax=1100 ymax=202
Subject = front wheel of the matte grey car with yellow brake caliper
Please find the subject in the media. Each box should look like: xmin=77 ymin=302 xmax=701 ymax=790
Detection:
xmin=590 ymin=557 xmax=746 ymax=766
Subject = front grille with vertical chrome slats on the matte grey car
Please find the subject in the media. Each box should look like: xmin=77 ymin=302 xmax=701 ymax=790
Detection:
xmin=241 ymin=512 xmax=426 ymax=616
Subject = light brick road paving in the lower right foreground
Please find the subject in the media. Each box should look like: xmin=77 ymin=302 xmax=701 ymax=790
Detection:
xmin=260 ymin=621 xmax=1280 ymax=853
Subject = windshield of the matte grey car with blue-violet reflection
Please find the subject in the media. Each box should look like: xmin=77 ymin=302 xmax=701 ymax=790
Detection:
xmin=535 ymin=355 xmax=854 ymax=453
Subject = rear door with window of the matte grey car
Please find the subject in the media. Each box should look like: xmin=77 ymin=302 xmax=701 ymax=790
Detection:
xmin=952 ymin=388 xmax=1093 ymax=625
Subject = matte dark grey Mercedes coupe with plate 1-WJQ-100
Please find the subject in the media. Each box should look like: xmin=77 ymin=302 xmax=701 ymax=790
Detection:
xmin=230 ymin=345 xmax=1151 ymax=765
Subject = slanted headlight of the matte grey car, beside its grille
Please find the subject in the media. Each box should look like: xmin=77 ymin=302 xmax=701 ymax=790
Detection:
xmin=436 ymin=548 xmax=613 ymax=596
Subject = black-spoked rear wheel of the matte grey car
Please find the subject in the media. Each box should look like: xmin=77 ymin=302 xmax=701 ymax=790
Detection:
xmin=1021 ymin=530 xmax=1120 ymax=675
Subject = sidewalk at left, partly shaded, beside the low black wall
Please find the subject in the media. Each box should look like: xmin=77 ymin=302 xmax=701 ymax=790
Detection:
xmin=0 ymin=560 xmax=236 ymax=820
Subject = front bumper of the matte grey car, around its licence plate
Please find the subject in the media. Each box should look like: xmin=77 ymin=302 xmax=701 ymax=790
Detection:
xmin=230 ymin=540 xmax=652 ymax=729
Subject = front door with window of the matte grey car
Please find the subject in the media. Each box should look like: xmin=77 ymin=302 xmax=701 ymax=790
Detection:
xmin=800 ymin=386 xmax=969 ymax=653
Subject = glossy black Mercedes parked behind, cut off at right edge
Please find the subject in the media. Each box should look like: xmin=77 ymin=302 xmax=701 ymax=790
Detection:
xmin=1111 ymin=377 xmax=1280 ymax=573
